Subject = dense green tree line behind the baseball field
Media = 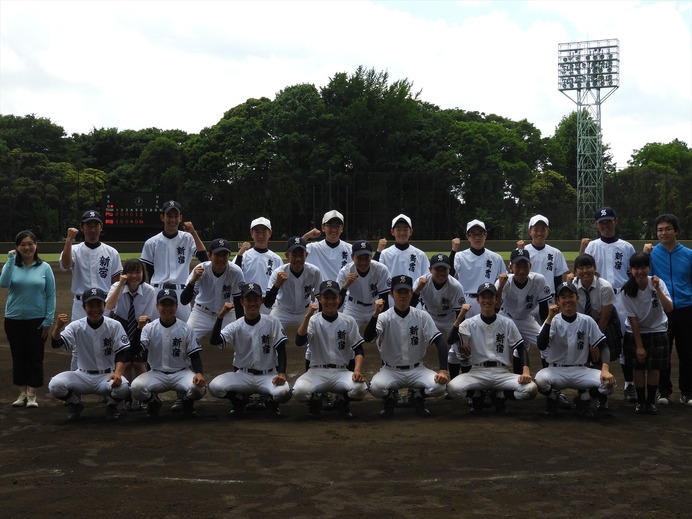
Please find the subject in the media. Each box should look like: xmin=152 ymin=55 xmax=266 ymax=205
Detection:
xmin=0 ymin=67 xmax=692 ymax=241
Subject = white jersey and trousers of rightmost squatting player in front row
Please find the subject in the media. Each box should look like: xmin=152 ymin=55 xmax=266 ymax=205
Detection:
xmin=535 ymin=313 xmax=615 ymax=394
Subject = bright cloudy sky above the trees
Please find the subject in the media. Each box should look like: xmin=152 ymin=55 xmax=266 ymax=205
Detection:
xmin=0 ymin=0 xmax=692 ymax=168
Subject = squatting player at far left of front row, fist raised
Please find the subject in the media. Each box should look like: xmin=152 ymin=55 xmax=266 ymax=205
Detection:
xmin=48 ymin=288 xmax=130 ymax=421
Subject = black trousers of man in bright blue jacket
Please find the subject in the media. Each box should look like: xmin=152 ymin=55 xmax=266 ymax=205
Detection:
xmin=658 ymin=306 xmax=692 ymax=397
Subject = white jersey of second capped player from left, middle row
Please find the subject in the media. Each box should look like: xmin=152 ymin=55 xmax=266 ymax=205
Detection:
xmin=269 ymin=263 xmax=322 ymax=326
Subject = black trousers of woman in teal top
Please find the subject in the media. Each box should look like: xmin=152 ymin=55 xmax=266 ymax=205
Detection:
xmin=5 ymin=318 xmax=45 ymax=387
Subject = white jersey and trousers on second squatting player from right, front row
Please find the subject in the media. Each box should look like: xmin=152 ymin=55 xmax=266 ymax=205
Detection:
xmin=447 ymin=314 xmax=537 ymax=400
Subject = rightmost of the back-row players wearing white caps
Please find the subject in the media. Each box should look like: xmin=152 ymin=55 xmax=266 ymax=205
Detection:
xmin=517 ymin=214 xmax=569 ymax=296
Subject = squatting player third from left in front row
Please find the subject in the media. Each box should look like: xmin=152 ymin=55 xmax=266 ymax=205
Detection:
xmin=209 ymin=283 xmax=291 ymax=416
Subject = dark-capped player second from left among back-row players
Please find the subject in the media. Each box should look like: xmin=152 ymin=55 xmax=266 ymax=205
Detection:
xmin=140 ymin=200 xmax=209 ymax=321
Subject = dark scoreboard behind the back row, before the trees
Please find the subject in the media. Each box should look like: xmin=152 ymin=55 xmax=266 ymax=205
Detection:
xmin=103 ymin=193 xmax=172 ymax=240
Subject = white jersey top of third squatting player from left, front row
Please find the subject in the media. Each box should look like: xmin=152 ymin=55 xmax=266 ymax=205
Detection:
xmin=221 ymin=315 xmax=288 ymax=370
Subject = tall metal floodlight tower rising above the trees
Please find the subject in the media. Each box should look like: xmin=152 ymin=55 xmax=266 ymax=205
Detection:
xmin=557 ymin=40 xmax=620 ymax=237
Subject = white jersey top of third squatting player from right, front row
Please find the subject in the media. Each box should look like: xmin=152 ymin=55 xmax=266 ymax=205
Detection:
xmin=377 ymin=307 xmax=441 ymax=366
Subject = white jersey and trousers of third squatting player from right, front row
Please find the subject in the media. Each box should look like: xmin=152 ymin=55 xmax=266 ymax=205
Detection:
xmin=370 ymin=308 xmax=445 ymax=398
